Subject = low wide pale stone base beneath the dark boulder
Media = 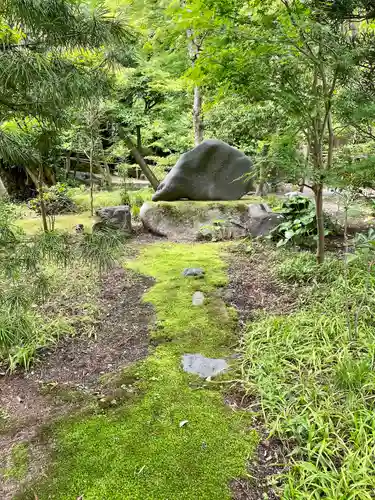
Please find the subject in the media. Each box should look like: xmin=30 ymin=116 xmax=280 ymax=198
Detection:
xmin=140 ymin=200 xmax=282 ymax=241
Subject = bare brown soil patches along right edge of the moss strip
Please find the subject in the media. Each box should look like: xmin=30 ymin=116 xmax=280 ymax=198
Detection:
xmin=225 ymin=248 xmax=298 ymax=500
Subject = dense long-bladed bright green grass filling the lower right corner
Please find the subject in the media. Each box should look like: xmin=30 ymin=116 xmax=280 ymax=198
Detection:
xmin=243 ymin=248 xmax=375 ymax=500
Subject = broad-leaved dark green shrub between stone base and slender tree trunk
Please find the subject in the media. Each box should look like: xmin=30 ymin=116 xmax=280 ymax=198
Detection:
xmin=271 ymin=196 xmax=334 ymax=247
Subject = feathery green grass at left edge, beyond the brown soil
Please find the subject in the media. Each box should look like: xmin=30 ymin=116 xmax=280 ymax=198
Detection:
xmin=0 ymin=203 xmax=125 ymax=370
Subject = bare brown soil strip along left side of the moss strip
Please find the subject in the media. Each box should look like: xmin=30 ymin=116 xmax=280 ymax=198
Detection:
xmin=0 ymin=268 xmax=153 ymax=500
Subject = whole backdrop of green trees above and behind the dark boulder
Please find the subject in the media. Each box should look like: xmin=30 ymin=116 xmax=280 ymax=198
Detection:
xmin=0 ymin=0 xmax=375 ymax=261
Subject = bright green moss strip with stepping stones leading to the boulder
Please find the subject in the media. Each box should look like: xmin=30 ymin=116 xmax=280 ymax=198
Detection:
xmin=22 ymin=244 xmax=257 ymax=500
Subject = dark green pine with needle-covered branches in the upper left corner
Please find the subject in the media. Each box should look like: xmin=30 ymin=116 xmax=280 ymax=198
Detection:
xmin=0 ymin=0 xmax=131 ymax=196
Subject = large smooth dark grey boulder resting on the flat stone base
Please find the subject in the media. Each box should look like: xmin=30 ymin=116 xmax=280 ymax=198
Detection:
xmin=152 ymin=139 xmax=253 ymax=201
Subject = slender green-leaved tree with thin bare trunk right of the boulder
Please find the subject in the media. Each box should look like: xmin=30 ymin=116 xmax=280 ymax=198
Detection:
xmin=188 ymin=0 xmax=374 ymax=262
